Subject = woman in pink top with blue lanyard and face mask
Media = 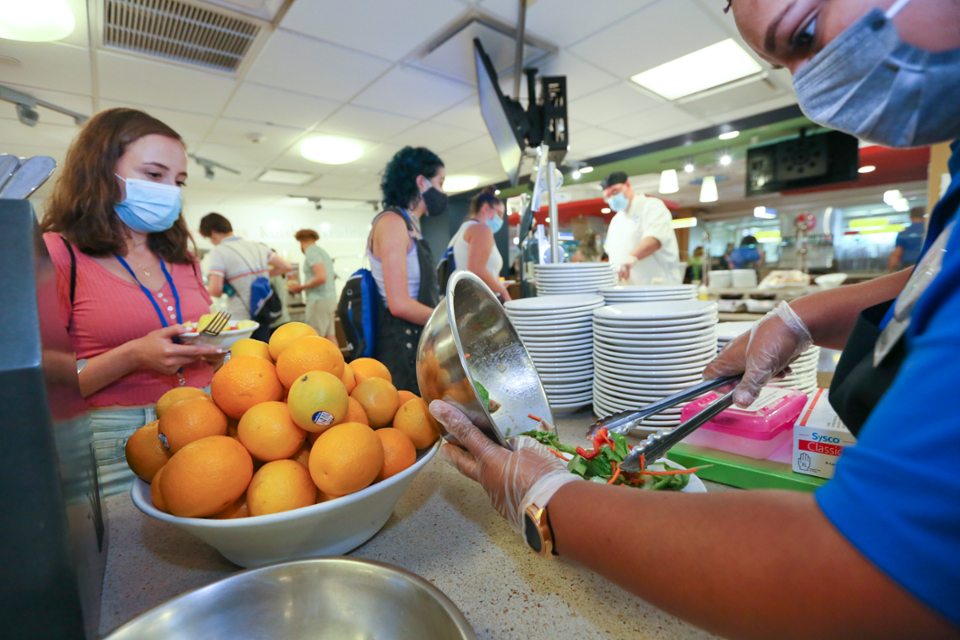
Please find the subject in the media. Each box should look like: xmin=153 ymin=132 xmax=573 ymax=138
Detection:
xmin=41 ymin=109 xmax=220 ymax=495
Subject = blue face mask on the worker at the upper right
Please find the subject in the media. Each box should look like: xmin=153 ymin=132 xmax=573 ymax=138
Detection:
xmin=793 ymin=0 xmax=960 ymax=147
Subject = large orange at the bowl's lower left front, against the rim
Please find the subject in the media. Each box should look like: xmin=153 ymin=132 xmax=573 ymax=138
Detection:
xmin=160 ymin=436 xmax=253 ymax=518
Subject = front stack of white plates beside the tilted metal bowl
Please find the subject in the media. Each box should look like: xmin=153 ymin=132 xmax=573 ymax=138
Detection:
xmin=504 ymin=294 xmax=603 ymax=413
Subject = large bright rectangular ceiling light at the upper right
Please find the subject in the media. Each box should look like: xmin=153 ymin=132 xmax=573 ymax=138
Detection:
xmin=631 ymin=38 xmax=763 ymax=100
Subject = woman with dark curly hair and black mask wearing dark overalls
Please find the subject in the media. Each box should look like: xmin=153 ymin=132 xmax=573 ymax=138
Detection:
xmin=367 ymin=147 xmax=447 ymax=393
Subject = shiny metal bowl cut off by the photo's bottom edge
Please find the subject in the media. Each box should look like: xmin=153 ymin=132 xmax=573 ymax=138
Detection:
xmin=104 ymin=558 xmax=477 ymax=640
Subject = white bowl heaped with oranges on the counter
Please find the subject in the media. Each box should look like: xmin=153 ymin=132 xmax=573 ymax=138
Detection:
xmin=126 ymin=323 xmax=440 ymax=567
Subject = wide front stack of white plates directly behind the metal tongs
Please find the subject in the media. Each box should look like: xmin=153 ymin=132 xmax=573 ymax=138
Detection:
xmin=593 ymin=300 xmax=717 ymax=429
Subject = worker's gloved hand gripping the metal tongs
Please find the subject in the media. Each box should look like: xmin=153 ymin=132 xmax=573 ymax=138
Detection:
xmin=703 ymin=302 xmax=813 ymax=407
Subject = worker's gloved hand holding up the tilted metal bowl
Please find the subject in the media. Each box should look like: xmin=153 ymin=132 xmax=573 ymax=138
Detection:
xmin=430 ymin=400 xmax=582 ymax=533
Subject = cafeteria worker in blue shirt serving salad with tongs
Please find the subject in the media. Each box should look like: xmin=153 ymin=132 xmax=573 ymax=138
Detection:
xmin=431 ymin=0 xmax=960 ymax=640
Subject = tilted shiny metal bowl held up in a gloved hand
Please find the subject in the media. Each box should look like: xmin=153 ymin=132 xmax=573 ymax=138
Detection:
xmin=417 ymin=271 xmax=553 ymax=448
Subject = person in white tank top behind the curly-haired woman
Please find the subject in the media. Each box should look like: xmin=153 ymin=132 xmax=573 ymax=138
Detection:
xmin=447 ymin=187 xmax=510 ymax=302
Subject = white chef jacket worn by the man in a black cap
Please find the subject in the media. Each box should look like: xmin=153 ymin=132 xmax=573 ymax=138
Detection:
xmin=604 ymin=193 xmax=683 ymax=284
